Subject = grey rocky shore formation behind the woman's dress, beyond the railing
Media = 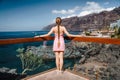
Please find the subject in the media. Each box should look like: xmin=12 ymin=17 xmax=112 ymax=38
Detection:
xmin=25 ymin=41 xmax=99 ymax=60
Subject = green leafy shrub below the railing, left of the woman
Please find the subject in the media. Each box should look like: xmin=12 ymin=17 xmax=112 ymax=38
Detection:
xmin=16 ymin=48 xmax=43 ymax=74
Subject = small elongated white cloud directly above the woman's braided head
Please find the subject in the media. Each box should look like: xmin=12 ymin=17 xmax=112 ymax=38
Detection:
xmin=52 ymin=6 xmax=79 ymax=14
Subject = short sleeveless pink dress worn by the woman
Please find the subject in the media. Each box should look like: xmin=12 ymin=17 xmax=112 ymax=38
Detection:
xmin=53 ymin=33 xmax=65 ymax=51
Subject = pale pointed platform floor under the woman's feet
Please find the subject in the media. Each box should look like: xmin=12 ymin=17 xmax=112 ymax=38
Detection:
xmin=22 ymin=69 xmax=89 ymax=80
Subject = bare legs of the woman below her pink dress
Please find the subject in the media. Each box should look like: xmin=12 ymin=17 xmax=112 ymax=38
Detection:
xmin=55 ymin=52 xmax=63 ymax=71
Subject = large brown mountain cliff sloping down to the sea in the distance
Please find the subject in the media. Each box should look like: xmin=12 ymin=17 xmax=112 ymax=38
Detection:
xmin=43 ymin=7 xmax=120 ymax=31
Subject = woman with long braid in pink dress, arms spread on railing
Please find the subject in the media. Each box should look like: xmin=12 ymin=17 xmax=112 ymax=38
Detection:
xmin=36 ymin=17 xmax=80 ymax=71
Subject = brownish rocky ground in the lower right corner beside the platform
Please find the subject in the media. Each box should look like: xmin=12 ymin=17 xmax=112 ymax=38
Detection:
xmin=76 ymin=44 xmax=120 ymax=80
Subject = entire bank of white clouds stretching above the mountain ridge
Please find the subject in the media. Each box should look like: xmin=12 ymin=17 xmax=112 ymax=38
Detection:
xmin=52 ymin=2 xmax=115 ymax=18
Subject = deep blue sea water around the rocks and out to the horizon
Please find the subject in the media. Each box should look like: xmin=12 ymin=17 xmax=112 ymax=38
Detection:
xmin=0 ymin=31 xmax=79 ymax=75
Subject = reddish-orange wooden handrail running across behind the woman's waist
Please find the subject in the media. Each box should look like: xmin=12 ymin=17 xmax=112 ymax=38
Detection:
xmin=0 ymin=36 xmax=120 ymax=45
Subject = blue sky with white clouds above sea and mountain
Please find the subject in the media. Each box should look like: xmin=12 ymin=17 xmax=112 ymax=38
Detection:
xmin=0 ymin=0 xmax=120 ymax=32
